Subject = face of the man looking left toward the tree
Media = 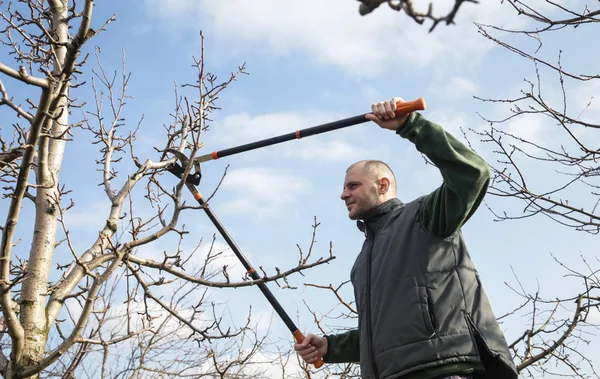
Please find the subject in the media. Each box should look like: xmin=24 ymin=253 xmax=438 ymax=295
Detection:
xmin=340 ymin=165 xmax=379 ymax=220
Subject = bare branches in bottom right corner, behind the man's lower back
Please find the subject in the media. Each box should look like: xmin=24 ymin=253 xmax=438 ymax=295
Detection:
xmin=499 ymin=257 xmax=600 ymax=378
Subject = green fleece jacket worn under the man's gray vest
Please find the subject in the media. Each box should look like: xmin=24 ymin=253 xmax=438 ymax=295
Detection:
xmin=323 ymin=113 xmax=490 ymax=379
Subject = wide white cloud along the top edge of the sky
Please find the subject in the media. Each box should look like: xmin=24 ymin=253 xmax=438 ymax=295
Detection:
xmin=145 ymin=0 xmax=556 ymax=76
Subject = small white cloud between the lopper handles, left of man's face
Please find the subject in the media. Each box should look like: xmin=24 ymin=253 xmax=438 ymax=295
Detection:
xmin=217 ymin=168 xmax=312 ymax=218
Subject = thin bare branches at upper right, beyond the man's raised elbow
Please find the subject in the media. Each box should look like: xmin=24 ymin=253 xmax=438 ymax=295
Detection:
xmin=478 ymin=1 xmax=600 ymax=234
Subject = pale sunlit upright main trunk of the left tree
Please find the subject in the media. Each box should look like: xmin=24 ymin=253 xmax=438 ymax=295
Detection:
xmin=17 ymin=1 xmax=69 ymax=377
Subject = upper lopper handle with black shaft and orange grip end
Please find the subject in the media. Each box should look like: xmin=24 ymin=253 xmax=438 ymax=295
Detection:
xmin=194 ymin=98 xmax=425 ymax=163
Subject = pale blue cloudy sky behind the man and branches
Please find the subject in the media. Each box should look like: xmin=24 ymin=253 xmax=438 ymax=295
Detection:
xmin=2 ymin=0 xmax=600 ymax=378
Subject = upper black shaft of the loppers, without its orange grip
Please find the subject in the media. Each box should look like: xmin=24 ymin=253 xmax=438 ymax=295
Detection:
xmin=213 ymin=113 xmax=369 ymax=158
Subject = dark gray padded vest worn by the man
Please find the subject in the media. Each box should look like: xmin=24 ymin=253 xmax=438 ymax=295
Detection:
xmin=350 ymin=199 xmax=517 ymax=379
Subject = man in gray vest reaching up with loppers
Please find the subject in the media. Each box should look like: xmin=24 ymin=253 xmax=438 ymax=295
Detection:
xmin=294 ymin=98 xmax=517 ymax=379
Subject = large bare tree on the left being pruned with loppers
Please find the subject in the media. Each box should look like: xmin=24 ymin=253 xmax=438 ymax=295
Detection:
xmin=0 ymin=0 xmax=334 ymax=378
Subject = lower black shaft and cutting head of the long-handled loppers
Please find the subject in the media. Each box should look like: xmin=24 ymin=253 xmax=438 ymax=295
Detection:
xmin=166 ymin=149 xmax=324 ymax=368
